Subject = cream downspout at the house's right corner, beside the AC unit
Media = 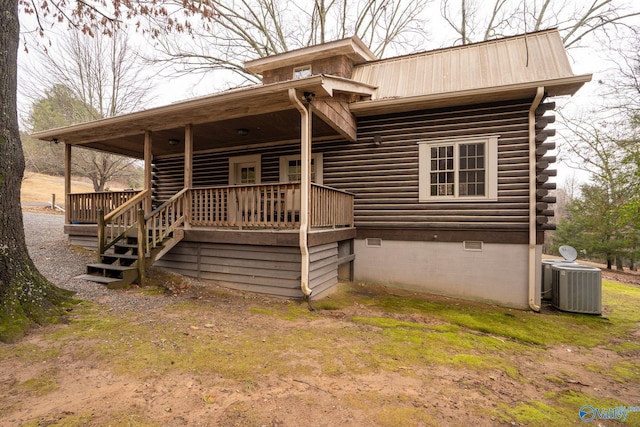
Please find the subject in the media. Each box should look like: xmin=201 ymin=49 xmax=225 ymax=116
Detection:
xmin=529 ymin=86 xmax=544 ymax=311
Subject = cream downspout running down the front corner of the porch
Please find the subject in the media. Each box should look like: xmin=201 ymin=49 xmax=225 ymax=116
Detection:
xmin=289 ymin=88 xmax=312 ymax=298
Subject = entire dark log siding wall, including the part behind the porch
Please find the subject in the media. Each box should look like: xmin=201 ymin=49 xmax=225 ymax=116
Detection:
xmin=154 ymin=99 xmax=532 ymax=243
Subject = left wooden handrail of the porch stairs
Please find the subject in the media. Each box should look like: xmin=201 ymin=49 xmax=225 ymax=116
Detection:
xmin=98 ymin=190 xmax=151 ymax=261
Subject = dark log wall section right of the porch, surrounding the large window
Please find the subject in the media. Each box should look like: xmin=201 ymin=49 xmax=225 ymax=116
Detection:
xmin=323 ymin=100 xmax=531 ymax=240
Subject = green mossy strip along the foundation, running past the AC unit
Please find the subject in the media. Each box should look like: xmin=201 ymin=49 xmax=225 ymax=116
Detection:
xmin=338 ymin=281 xmax=640 ymax=347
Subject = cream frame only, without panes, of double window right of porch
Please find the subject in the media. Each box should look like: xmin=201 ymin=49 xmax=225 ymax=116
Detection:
xmin=418 ymin=135 xmax=499 ymax=202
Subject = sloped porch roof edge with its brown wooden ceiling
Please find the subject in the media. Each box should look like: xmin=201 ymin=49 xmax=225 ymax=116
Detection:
xmin=33 ymin=75 xmax=375 ymax=158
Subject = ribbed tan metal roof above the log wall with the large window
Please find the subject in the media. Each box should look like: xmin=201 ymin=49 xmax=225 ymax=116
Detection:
xmin=352 ymin=29 xmax=591 ymax=102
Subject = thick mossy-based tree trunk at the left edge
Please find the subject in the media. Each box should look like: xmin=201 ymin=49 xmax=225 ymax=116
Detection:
xmin=0 ymin=0 xmax=69 ymax=341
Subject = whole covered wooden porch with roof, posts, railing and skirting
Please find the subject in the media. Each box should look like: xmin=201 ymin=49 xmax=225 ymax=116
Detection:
xmin=35 ymin=75 xmax=374 ymax=297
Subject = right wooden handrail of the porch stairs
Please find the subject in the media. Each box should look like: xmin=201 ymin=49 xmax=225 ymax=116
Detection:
xmin=144 ymin=188 xmax=189 ymax=253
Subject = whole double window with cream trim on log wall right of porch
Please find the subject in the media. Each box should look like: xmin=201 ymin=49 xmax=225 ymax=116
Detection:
xmin=418 ymin=135 xmax=498 ymax=202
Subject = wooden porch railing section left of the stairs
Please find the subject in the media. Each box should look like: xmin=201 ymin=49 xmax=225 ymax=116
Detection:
xmin=65 ymin=190 xmax=138 ymax=224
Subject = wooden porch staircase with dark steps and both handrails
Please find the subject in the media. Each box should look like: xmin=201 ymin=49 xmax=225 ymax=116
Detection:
xmin=77 ymin=190 xmax=187 ymax=289
